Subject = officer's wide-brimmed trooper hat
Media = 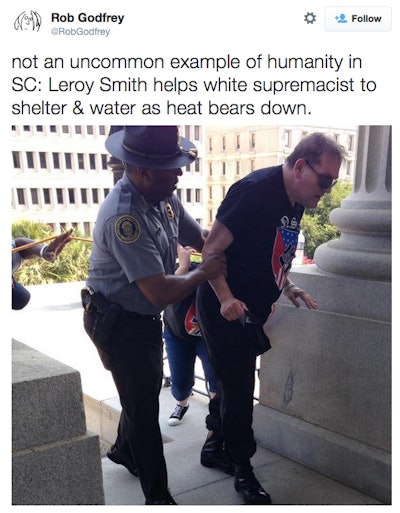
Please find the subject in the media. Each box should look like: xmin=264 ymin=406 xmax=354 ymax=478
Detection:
xmin=105 ymin=126 xmax=197 ymax=169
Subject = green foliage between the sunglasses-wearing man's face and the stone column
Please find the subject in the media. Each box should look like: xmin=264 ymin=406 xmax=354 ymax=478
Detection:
xmin=301 ymin=180 xmax=353 ymax=258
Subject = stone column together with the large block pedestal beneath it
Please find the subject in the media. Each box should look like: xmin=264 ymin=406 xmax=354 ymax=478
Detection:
xmin=253 ymin=126 xmax=392 ymax=504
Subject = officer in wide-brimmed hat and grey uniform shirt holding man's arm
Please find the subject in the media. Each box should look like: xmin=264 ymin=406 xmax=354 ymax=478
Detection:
xmin=82 ymin=126 xmax=226 ymax=505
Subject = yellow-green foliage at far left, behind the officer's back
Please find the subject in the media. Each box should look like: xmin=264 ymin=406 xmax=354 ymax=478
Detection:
xmin=12 ymin=220 xmax=92 ymax=285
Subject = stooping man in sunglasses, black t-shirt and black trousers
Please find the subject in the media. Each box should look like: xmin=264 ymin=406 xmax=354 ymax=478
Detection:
xmin=196 ymin=133 xmax=344 ymax=504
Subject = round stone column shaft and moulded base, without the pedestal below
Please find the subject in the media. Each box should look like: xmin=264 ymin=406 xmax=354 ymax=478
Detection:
xmin=314 ymin=126 xmax=392 ymax=281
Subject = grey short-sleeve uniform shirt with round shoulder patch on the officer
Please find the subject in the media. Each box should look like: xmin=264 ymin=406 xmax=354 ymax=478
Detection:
xmin=87 ymin=175 xmax=201 ymax=314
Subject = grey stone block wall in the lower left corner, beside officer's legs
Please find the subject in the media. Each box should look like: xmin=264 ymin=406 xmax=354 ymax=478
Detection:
xmin=12 ymin=341 xmax=104 ymax=505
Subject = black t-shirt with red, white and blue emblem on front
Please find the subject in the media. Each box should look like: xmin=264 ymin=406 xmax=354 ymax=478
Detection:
xmin=217 ymin=166 xmax=304 ymax=322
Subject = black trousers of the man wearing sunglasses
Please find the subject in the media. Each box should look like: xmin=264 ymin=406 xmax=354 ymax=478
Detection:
xmin=196 ymin=284 xmax=256 ymax=463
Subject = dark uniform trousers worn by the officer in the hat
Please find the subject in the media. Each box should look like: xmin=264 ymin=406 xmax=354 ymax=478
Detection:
xmin=84 ymin=312 xmax=168 ymax=501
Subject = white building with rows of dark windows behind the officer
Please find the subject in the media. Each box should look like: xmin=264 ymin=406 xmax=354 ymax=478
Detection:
xmin=11 ymin=125 xmax=205 ymax=236
